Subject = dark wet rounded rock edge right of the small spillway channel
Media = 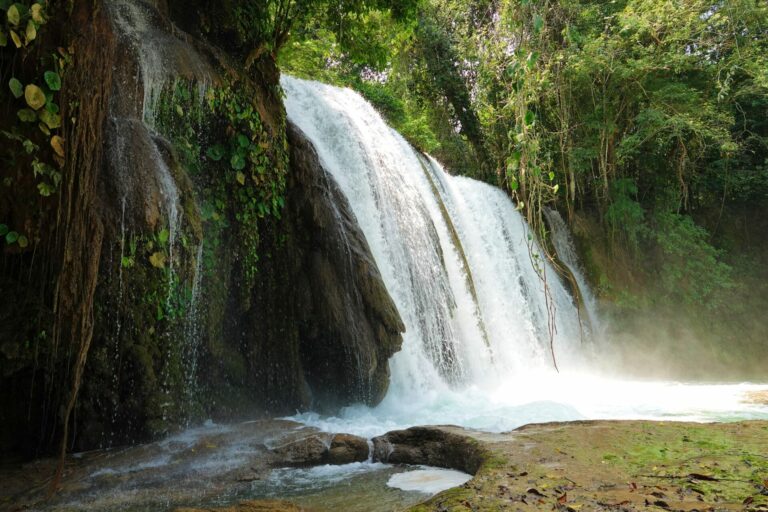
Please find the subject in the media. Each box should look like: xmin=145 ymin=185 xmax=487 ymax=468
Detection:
xmin=373 ymin=427 xmax=485 ymax=474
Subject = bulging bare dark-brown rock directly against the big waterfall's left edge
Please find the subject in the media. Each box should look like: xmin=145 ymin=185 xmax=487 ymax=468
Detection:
xmin=252 ymin=125 xmax=405 ymax=409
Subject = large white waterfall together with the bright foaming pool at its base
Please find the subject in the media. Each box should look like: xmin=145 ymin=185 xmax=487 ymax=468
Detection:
xmin=282 ymin=77 xmax=768 ymax=436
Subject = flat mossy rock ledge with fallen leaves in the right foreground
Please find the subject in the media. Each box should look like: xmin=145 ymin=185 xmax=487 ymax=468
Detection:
xmin=179 ymin=421 xmax=768 ymax=512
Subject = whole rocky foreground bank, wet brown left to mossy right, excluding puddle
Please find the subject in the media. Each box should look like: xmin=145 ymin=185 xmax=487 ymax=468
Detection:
xmin=0 ymin=421 xmax=768 ymax=512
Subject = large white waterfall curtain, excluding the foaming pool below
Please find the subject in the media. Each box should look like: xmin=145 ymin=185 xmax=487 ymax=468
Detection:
xmin=282 ymin=77 xmax=580 ymax=402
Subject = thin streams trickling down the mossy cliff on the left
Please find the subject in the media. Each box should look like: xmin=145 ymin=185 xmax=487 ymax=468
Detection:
xmin=106 ymin=0 xmax=208 ymax=430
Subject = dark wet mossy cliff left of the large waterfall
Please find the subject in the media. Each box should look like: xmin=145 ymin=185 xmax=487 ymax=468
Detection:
xmin=0 ymin=0 xmax=404 ymax=460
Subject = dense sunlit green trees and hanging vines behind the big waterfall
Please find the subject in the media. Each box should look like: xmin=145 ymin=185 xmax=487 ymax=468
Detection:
xmin=281 ymin=0 xmax=768 ymax=368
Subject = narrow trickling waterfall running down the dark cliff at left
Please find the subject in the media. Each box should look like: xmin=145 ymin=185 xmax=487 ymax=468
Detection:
xmin=106 ymin=0 xmax=214 ymax=432
